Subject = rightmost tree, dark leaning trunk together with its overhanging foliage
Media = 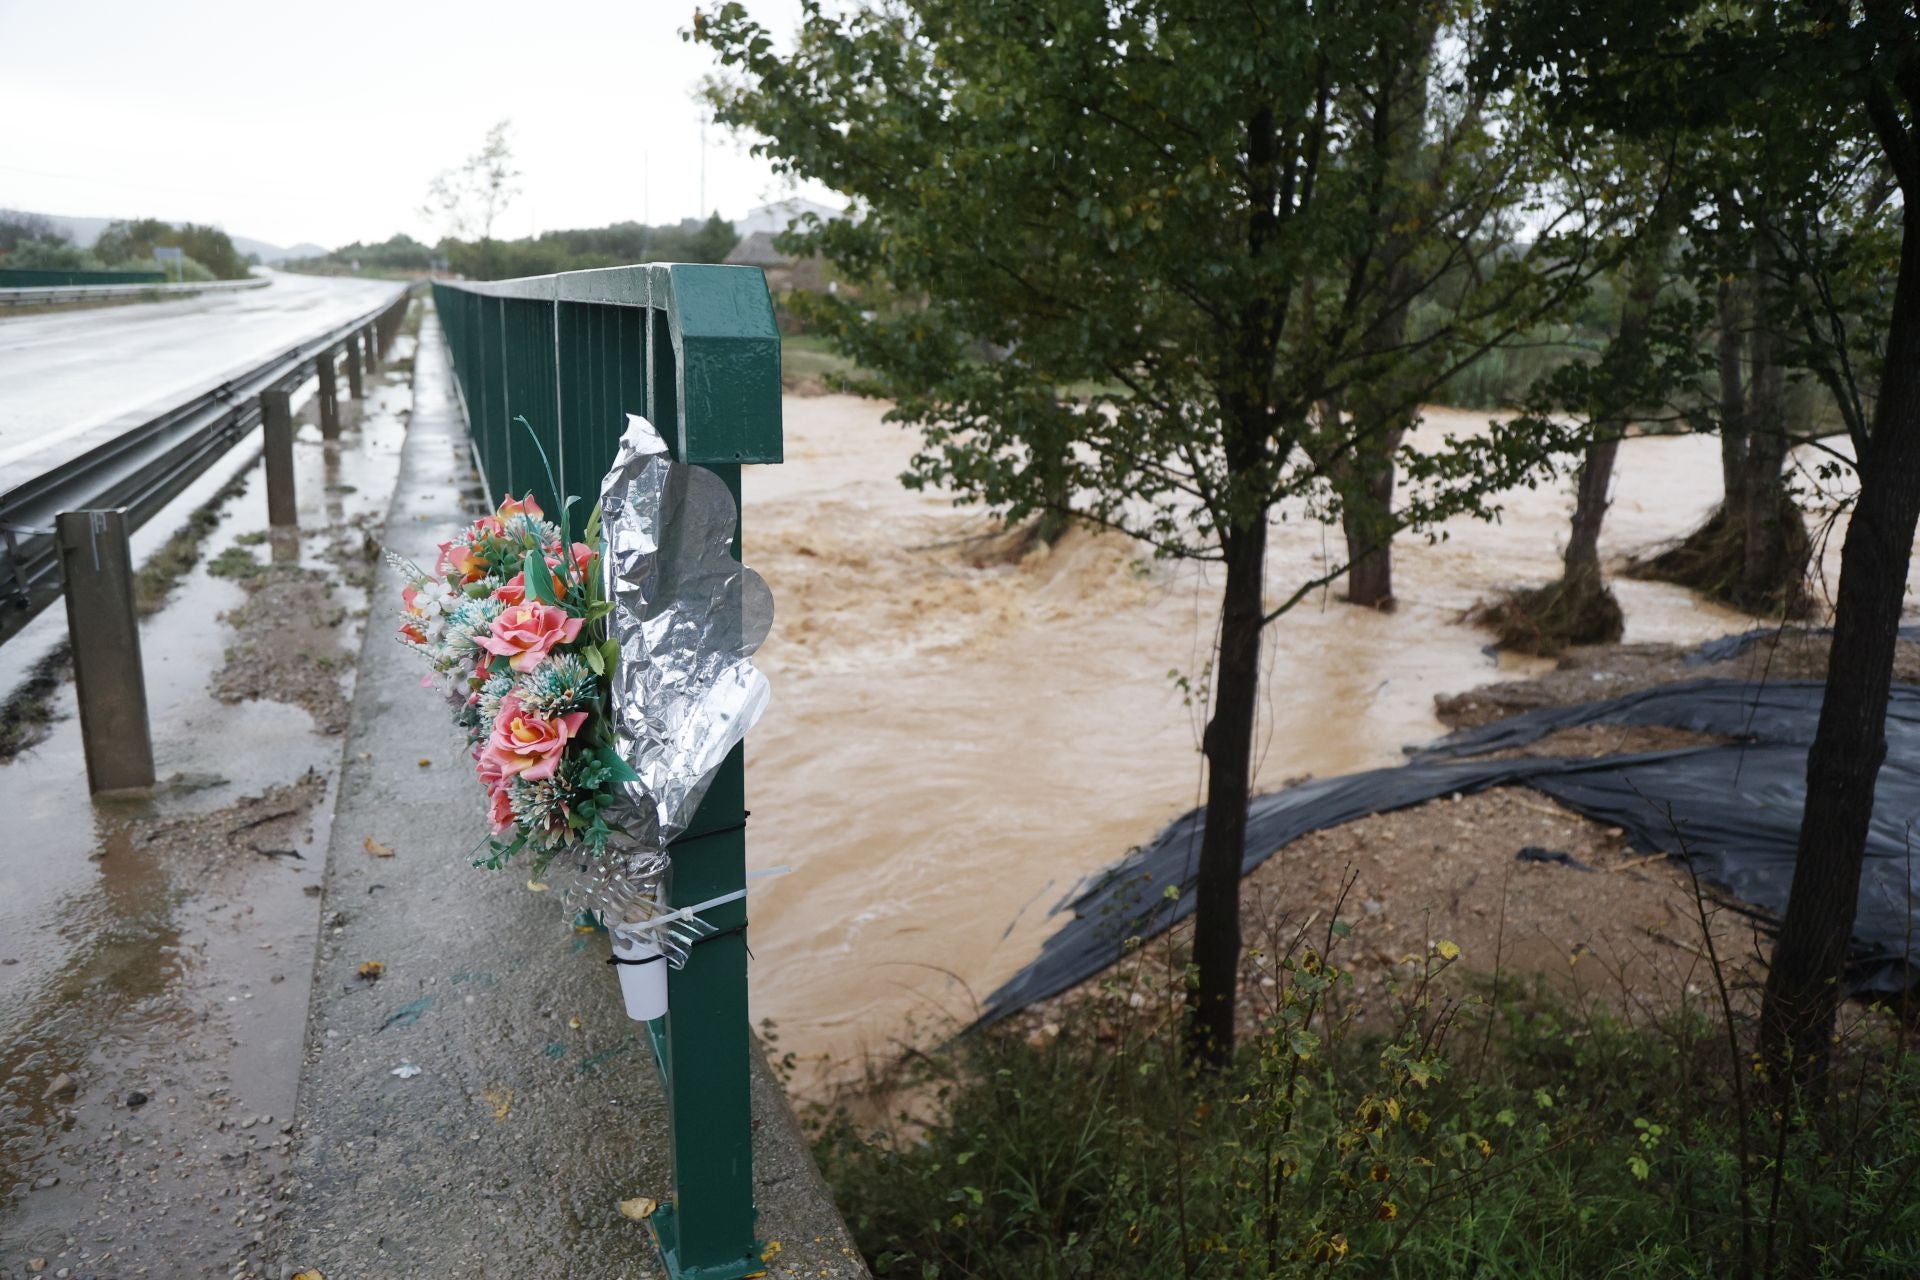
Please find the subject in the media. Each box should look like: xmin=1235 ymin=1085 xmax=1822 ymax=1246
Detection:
xmin=1498 ymin=0 xmax=1920 ymax=1096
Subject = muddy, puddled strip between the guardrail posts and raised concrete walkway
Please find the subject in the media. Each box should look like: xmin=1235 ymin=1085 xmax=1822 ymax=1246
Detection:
xmin=0 ymin=322 xmax=413 ymax=1276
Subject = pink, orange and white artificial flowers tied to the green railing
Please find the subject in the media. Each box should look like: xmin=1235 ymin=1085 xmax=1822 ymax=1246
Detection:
xmin=396 ymin=493 xmax=636 ymax=875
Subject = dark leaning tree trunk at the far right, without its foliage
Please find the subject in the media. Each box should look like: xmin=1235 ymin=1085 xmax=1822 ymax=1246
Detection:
xmin=1761 ymin=205 xmax=1920 ymax=1100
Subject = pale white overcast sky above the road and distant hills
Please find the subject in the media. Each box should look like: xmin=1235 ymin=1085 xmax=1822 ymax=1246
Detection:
xmin=0 ymin=0 xmax=829 ymax=248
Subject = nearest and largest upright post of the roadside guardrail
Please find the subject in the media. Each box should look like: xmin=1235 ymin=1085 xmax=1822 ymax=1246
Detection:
xmin=54 ymin=510 xmax=154 ymax=793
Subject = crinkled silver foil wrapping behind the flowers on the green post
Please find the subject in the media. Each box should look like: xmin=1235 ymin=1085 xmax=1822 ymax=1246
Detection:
xmin=564 ymin=415 xmax=774 ymax=951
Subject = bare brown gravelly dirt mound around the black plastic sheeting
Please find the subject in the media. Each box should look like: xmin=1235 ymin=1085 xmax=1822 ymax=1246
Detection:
xmin=1016 ymin=631 xmax=1920 ymax=1036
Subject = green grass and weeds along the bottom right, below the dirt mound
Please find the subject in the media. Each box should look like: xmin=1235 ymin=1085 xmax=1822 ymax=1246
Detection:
xmin=812 ymin=905 xmax=1920 ymax=1280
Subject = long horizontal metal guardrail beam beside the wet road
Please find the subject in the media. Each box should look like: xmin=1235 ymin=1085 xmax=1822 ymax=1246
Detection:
xmin=0 ymin=286 xmax=409 ymax=641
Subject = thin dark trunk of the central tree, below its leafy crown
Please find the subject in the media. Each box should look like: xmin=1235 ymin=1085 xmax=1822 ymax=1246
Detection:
xmin=1188 ymin=510 xmax=1267 ymax=1065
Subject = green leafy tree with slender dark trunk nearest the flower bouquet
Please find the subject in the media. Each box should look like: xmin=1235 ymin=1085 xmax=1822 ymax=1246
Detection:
xmin=689 ymin=0 xmax=1611 ymax=1063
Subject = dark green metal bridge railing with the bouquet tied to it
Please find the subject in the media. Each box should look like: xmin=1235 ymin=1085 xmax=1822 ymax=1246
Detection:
xmin=434 ymin=265 xmax=781 ymax=1280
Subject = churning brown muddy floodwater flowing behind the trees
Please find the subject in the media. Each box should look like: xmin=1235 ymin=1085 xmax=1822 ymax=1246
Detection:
xmin=745 ymin=395 xmax=1812 ymax=1094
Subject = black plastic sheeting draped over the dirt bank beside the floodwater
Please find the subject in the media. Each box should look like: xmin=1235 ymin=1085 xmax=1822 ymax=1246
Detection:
xmin=979 ymin=679 xmax=1920 ymax=1023
